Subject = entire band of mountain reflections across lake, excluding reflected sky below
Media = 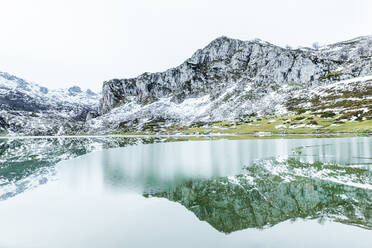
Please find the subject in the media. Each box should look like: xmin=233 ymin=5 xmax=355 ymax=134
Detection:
xmin=0 ymin=137 xmax=372 ymax=233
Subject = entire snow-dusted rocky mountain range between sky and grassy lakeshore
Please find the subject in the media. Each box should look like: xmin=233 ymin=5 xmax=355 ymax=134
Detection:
xmin=0 ymin=36 xmax=372 ymax=135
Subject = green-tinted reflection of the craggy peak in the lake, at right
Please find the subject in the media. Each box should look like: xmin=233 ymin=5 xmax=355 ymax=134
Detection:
xmin=145 ymin=159 xmax=372 ymax=233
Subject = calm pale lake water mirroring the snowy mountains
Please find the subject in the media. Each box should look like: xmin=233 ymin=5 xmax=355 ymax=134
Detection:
xmin=0 ymin=137 xmax=372 ymax=247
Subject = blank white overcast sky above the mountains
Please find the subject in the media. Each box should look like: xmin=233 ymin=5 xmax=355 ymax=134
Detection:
xmin=0 ymin=0 xmax=372 ymax=91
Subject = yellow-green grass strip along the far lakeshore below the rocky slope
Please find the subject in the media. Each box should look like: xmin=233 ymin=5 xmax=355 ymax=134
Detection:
xmin=161 ymin=114 xmax=372 ymax=135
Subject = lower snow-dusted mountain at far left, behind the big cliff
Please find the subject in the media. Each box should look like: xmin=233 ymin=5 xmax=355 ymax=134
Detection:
xmin=0 ymin=72 xmax=100 ymax=135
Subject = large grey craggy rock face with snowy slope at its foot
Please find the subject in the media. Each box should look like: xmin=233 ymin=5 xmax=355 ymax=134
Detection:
xmin=91 ymin=37 xmax=372 ymax=133
